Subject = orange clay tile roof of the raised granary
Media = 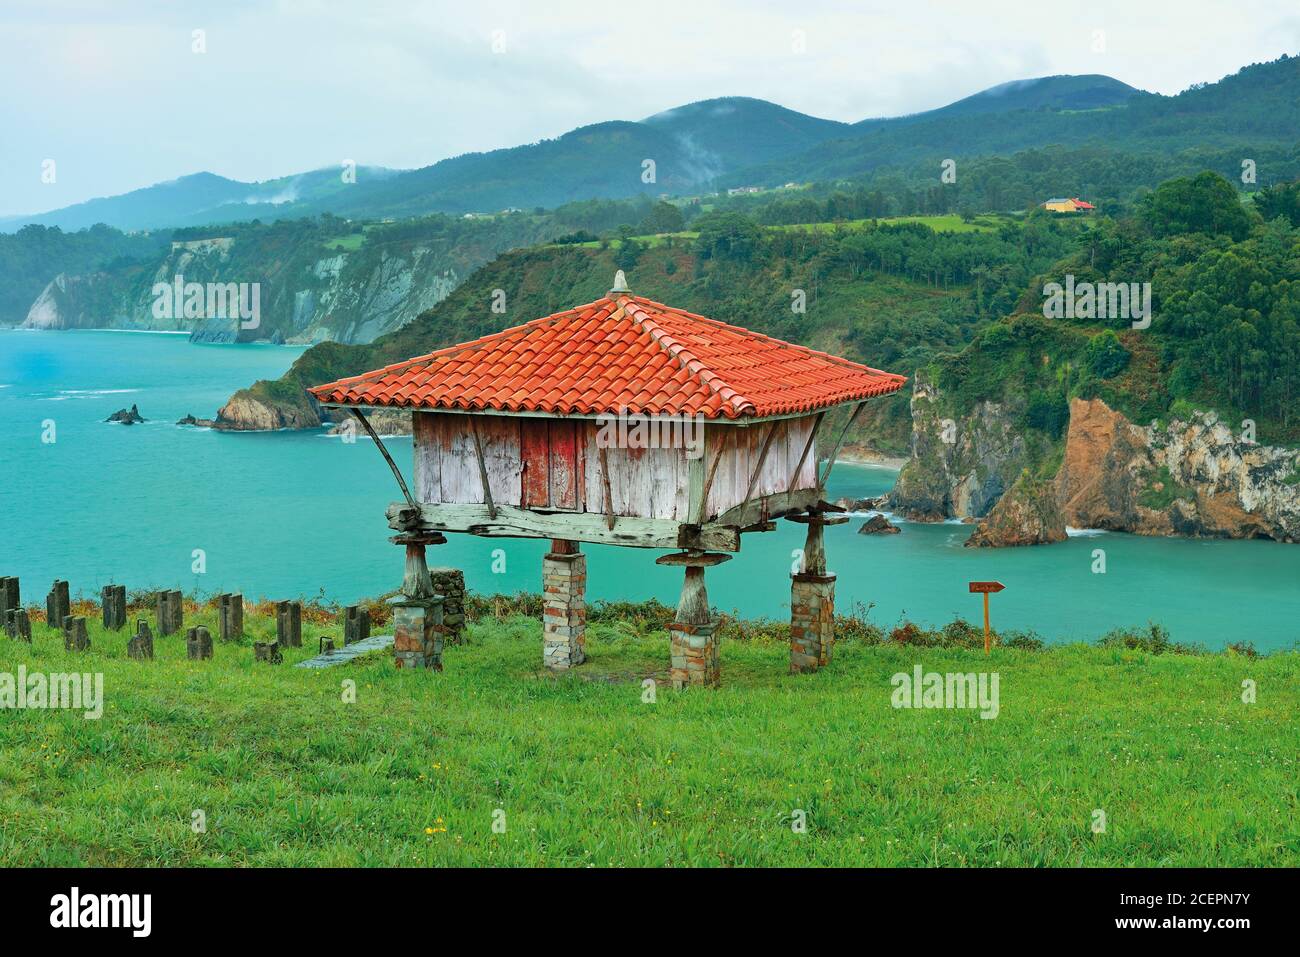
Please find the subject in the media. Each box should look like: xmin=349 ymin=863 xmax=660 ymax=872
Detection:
xmin=311 ymin=293 xmax=907 ymax=419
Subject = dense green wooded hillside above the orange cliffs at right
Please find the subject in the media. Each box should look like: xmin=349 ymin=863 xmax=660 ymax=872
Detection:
xmin=931 ymin=173 xmax=1300 ymax=452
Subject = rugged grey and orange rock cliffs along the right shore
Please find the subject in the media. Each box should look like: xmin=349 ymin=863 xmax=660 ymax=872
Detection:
xmin=891 ymin=381 xmax=1300 ymax=546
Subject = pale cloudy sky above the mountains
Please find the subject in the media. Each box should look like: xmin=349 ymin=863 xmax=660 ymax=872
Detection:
xmin=0 ymin=0 xmax=1300 ymax=215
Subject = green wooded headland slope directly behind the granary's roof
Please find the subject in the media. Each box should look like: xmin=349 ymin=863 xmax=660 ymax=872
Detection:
xmin=222 ymin=213 xmax=1083 ymax=452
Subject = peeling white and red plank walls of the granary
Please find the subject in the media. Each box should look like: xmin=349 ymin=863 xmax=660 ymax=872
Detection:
xmin=413 ymin=412 xmax=816 ymax=521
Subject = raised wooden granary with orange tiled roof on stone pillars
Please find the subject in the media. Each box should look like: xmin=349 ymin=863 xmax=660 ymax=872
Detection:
xmin=311 ymin=272 xmax=906 ymax=687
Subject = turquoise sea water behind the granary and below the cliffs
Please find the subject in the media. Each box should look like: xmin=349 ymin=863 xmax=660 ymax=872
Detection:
xmin=0 ymin=330 xmax=1300 ymax=650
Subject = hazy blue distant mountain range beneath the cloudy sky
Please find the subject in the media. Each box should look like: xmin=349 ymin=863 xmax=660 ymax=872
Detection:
xmin=0 ymin=75 xmax=1151 ymax=231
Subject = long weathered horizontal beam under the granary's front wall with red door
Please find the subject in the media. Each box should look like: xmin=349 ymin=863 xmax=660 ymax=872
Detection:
xmin=387 ymin=502 xmax=740 ymax=551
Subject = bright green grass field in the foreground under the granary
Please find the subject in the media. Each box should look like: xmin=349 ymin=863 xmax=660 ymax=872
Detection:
xmin=0 ymin=610 xmax=1300 ymax=866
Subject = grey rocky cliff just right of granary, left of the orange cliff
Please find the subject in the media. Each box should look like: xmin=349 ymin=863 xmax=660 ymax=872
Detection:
xmin=889 ymin=372 xmax=1026 ymax=521
